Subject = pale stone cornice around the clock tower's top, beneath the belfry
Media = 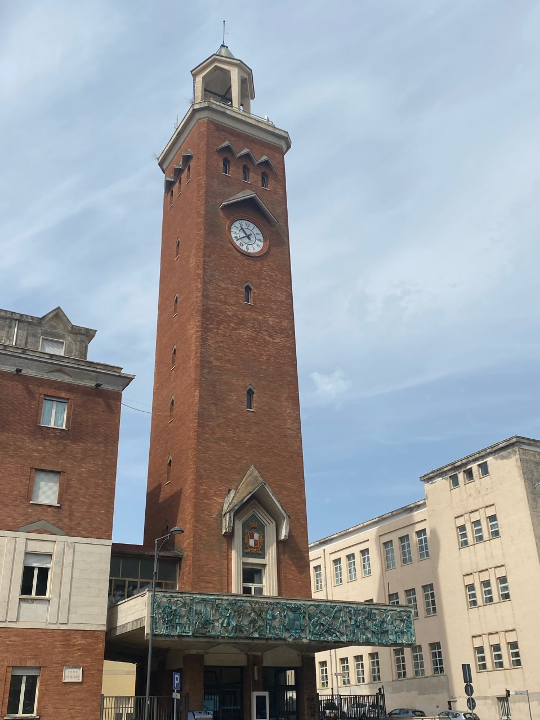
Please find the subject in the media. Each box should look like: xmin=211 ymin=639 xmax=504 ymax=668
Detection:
xmin=158 ymin=100 xmax=291 ymax=172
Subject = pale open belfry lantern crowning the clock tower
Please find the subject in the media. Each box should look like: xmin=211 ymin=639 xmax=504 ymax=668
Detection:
xmin=191 ymin=45 xmax=255 ymax=113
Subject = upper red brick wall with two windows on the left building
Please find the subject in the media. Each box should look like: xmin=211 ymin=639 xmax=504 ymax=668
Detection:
xmin=0 ymin=372 xmax=121 ymax=539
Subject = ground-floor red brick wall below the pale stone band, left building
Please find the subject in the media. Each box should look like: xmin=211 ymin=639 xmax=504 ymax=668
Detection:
xmin=0 ymin=628 xmax=105 ymax=720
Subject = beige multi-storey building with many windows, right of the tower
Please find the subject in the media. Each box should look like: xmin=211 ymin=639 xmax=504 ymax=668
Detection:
xmin=310 ymin=437 xmax=540 ymax=720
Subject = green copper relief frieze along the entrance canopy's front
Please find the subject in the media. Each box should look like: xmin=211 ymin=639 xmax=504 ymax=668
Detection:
xmin=154 ymin=593 xmax=415 ymax=645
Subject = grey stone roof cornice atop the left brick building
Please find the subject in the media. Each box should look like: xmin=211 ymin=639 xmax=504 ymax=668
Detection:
xmin=0 ymin=344 xmax=135 ymax=392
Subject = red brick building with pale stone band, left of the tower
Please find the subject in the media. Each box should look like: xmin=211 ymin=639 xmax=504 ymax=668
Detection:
xmin=0 ymin=308 xmax=132 ymax=720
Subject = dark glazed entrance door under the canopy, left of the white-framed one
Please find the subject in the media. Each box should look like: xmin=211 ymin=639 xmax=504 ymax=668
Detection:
xmin=204 ymin=666 xmax=244 ymax=720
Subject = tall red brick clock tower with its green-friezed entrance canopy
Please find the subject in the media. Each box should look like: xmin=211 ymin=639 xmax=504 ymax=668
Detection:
xmin=108 ymin=45 xmax=414 ymax=720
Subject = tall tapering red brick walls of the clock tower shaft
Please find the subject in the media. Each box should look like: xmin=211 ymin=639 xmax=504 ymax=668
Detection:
xmin=145 ymin=115 xmax=310 ymax=597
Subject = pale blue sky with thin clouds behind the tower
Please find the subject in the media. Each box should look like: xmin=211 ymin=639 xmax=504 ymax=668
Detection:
xmin=0 ymin=0 xmax=540 ymax=542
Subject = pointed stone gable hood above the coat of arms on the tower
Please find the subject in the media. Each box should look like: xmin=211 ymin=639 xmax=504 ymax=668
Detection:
xmin=222 ymin=465 xmax=290 ymax=540
